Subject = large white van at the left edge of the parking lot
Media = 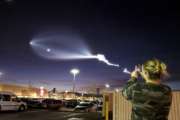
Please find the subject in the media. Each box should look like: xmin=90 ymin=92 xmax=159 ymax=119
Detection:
xmin=0 ymin=91 xmax=27 ymax=111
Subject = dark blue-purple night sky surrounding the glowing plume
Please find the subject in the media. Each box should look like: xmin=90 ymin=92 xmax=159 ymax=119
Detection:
xmin=0 ymin=0 xmax=180 ymax=89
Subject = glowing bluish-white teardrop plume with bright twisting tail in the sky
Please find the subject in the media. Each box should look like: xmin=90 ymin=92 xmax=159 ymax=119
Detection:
xmin=29 ymin=33 xmax=119 ymax=67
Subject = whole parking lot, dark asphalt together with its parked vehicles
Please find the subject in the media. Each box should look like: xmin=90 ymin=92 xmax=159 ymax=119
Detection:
xmin=0 ymin=92 xmax=102 ymax=120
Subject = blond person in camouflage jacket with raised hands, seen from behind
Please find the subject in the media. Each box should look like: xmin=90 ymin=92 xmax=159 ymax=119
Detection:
xmin=122 ymin=59 xmax=172 ymax=120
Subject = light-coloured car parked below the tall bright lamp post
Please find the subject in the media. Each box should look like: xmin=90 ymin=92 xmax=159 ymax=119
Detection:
xmin=74 ymin=102 xmax=97 ymax=112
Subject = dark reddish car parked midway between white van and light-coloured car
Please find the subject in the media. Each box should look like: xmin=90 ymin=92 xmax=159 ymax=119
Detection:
xmin=42 ymin=99 xmax=63 ymax=109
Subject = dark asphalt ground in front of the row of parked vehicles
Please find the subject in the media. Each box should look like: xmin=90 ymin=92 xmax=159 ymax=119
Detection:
xmin=0 ymin=109 xmax=101 ymax=120
